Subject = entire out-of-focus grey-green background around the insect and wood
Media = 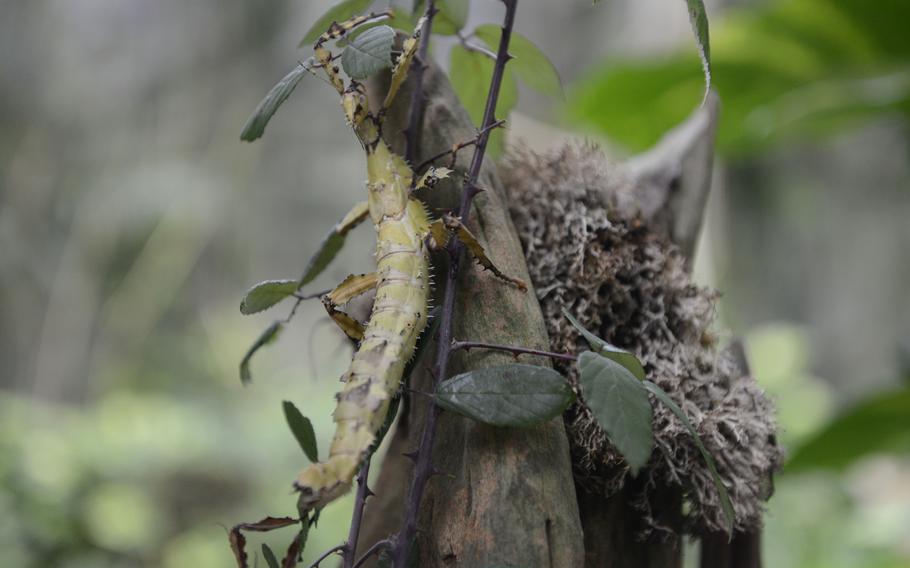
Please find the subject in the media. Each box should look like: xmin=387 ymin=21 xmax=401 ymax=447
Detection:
xmin=0 ymin=0 xmax=910 ymax=568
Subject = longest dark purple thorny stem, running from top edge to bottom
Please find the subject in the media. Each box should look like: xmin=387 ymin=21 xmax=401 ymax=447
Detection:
xmin=392 ymin=0 xmax=518 ymax=568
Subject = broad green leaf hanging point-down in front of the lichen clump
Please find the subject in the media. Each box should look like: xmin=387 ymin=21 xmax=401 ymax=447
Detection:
xmin=578 ymin=351 xmax=654 ymax=475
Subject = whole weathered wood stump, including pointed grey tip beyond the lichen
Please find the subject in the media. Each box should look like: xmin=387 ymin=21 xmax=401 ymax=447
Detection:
xmin=359 ymin=57 xmax=760 ymax=568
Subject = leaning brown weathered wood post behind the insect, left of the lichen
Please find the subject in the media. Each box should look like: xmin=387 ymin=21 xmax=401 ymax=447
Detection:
xmin=358 ymin=57 xmax=584 ymax=567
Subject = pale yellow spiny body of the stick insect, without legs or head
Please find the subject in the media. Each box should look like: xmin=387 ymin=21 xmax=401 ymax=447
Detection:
xmin=294 ymin=140 xmax=429 ymax=509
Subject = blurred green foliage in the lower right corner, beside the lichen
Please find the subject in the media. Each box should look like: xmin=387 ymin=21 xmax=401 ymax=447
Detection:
xmin=746 ymin=323 xmax=910 ymax=568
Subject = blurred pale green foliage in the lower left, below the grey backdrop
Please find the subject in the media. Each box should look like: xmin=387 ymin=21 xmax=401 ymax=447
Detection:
xmin=0 ymin=376 xmax=364 ymax=568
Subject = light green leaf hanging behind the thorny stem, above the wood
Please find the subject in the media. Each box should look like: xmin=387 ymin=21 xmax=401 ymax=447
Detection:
xmin=449 ymin=45 xmax=518 ymax=157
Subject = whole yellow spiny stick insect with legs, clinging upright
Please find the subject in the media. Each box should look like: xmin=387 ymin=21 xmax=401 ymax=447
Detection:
xmin=286 ymin=14 xmax=526 ymax=511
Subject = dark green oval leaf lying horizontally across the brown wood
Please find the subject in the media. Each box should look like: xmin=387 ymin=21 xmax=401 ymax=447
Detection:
xmin=434 ymin=363 xmax=575 ymax=427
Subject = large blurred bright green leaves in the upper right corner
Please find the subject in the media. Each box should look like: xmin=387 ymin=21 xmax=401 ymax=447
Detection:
xmin=566 ymin=0 xmax=910 ymax=156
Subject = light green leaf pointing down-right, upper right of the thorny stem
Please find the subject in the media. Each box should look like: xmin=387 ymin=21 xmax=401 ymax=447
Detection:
xmin=474 ymin=24 xmax=565 ymax=99
